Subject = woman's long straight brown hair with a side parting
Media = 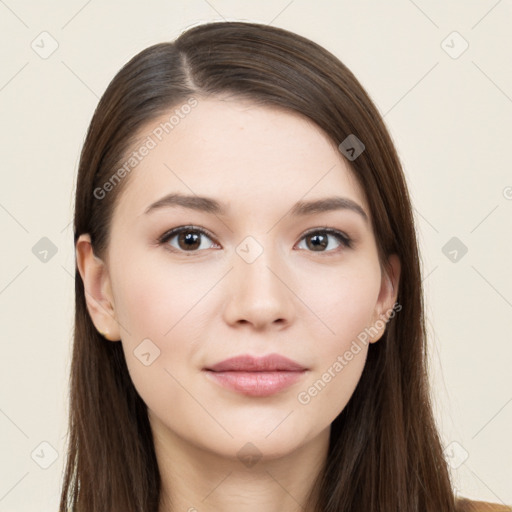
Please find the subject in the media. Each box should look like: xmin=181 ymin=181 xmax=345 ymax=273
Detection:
xmin=60 ymin=22 xmax=455 ymax=512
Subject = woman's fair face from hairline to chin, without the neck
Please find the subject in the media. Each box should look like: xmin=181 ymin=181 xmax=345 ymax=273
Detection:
xmin=79 ymin=98 xmax=399 ymax=458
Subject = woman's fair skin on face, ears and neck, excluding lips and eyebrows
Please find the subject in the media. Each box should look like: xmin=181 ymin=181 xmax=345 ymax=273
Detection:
xmin=76 ymin=97 xmax=400 ymax=512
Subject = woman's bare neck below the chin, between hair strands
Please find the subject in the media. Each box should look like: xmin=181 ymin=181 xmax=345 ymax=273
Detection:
xmin=153 ymin=414 xmax=329 ymax=512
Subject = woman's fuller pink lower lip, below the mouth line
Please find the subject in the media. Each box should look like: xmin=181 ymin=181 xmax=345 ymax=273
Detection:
xmin=206 ymin=370 xmax=306 ymax=396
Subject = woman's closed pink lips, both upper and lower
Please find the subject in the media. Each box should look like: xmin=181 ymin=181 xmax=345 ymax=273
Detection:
xmin=203 ymin=354 xmax=308 ymax=397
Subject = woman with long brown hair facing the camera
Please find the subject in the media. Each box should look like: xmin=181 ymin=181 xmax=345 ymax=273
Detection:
xmin=61 ymin=22 xmax=510 ymax=512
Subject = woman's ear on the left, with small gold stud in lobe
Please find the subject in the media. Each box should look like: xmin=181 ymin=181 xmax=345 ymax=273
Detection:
xmin=75 ymin=234 xmax=121 ymax=341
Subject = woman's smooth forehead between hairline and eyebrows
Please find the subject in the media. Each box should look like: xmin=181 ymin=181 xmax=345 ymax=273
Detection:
xmin=113 ymin=98 xmax=368 ymax=221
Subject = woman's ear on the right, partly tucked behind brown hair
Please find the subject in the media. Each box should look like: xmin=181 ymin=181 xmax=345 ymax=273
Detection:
xmin=369 ymin=254 xmax=401 ymax=343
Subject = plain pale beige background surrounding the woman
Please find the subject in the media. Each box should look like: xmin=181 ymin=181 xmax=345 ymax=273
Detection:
xmin=0 ymin=0 xmax=512 ymax=512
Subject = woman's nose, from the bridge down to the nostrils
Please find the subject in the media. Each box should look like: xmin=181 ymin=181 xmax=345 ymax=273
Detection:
xmin=224 ymin=245 xmax=295 ymax=330
